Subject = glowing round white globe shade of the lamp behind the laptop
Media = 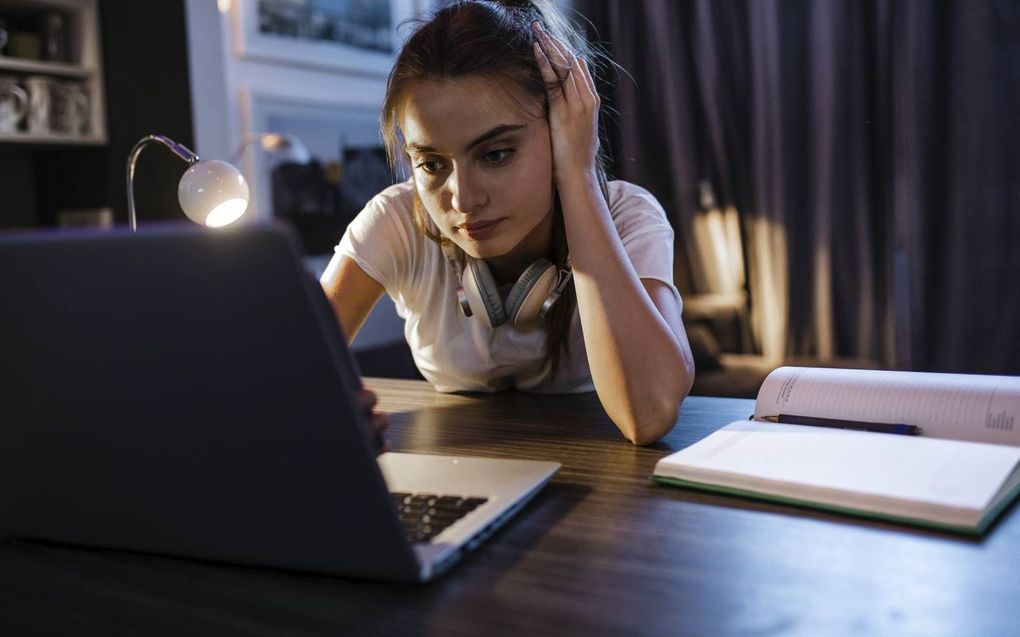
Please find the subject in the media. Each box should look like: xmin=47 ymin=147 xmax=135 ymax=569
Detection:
xmin=177 ymin=159 xmax=248 ymax=227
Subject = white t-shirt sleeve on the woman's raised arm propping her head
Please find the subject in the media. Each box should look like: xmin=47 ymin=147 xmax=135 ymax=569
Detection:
xmin=610 ymin=182 xmax=679 ymax=298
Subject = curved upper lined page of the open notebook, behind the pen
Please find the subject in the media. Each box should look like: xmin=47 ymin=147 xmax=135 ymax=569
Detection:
xmin=755 ymin=367 xmax=1020 ymax=446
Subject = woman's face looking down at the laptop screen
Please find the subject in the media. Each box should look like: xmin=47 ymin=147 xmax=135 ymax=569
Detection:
xmin=401 ymin=74 xmax=553 ymax=261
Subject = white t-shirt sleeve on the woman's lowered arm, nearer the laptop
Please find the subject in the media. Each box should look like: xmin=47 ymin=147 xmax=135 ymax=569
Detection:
xmin=334 ymin=183 xmax=418 ymax=296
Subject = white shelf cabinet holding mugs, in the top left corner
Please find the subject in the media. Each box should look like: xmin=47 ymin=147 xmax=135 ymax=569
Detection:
xmin=0 ymin=0 xmax=106 ymax=146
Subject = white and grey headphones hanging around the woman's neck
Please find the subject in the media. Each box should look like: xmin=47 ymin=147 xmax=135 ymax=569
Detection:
xmin=443 ymin=246 xmax=573 ymax=328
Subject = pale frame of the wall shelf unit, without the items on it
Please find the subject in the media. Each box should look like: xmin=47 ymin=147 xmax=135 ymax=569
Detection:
xmin=0 ymin=0 xmax=106 ymax=146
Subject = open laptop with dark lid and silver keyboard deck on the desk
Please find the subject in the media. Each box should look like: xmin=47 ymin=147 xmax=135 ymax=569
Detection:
xmin=0 ymin=224 xmax=559 ymax=581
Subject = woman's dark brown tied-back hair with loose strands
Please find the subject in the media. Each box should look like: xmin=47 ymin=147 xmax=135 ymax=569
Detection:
xmin=381 ymin=0 xmax=608 ymax=377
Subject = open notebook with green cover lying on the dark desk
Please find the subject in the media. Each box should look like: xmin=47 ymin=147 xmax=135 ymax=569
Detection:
xmin=652 ymin=367 xmax=1020 ymax=534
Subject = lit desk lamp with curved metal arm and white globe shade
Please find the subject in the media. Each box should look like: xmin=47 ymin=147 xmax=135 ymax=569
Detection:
xmin=128 ymin=135 xmax=248 ymax=230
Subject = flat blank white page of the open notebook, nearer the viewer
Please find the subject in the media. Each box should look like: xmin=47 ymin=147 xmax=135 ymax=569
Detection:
xmin=656 ymin=421 xmax=1020 ymax=514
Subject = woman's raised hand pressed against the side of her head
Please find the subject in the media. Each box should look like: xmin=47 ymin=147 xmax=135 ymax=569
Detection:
xmin=531 ymin=22 xmax=600 ymax=188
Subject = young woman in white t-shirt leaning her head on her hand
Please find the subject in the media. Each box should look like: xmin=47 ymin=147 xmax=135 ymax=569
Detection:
xmin=321 ymin=1 xmax=695 ymax=444
